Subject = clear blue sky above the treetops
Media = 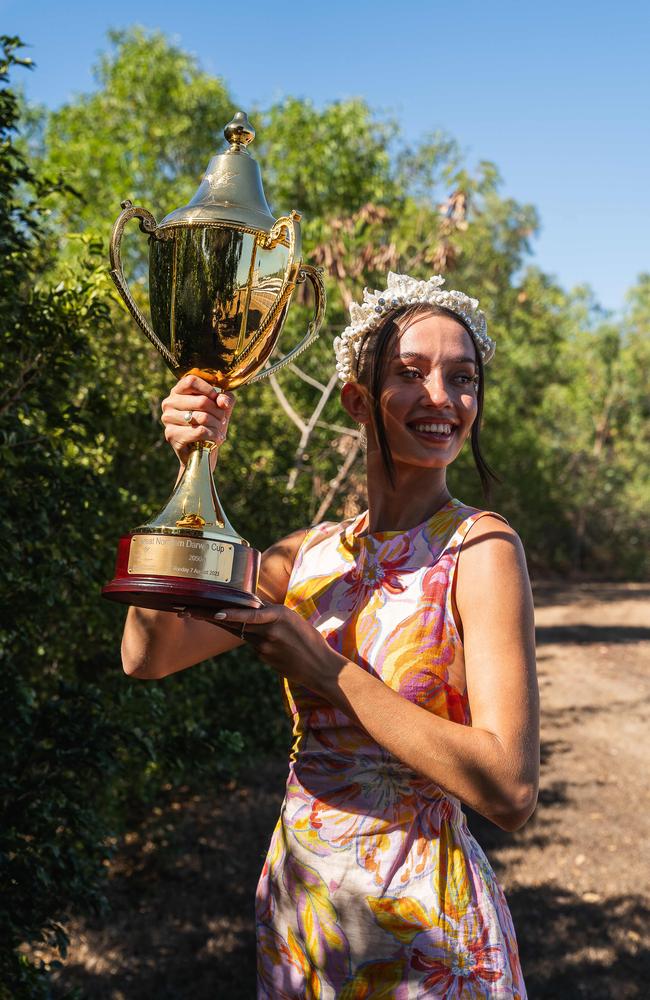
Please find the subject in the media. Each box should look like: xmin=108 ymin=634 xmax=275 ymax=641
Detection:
xmin=0 ymin=0 xmax=650 ymax=312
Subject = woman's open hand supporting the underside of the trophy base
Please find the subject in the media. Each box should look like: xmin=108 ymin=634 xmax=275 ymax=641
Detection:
xmin=199 ymin=604 xmax=339 ymax=692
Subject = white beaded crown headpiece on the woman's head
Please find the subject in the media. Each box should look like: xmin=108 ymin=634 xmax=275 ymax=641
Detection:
xmin=334 ymin=271 xmax=496 ymax=382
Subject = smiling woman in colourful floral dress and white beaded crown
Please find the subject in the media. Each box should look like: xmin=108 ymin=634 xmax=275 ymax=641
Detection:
xmin=123 ymin=274 xmax=539 ymax=1000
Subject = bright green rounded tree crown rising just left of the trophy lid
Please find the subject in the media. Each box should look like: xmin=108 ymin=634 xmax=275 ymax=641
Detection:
xmin=45 ymin=28 xmax=233 ymax=232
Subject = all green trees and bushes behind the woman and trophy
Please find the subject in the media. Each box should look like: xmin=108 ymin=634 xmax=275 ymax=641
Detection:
xmin=0 ymin=29 xmax=650 ymax=998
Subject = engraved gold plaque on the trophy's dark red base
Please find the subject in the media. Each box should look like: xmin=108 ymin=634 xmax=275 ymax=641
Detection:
xmin=129 ymin=534 xmax=235 ymax=583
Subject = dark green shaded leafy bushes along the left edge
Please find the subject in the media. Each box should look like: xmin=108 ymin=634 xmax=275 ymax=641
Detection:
xmin=0 ymin=33 xmax=260 ymax=998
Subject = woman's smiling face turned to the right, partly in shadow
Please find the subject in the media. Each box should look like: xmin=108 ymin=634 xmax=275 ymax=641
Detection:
xmin=380 ymin=315 xmax=478 ymax=468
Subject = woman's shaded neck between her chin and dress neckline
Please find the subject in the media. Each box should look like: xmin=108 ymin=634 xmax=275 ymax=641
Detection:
xmin=368 ymin=462 xmax=451 ymax=533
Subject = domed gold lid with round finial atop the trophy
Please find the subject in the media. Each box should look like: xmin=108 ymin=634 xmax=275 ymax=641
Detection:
xmin=158 ymin=111 xmax=275 ymax=232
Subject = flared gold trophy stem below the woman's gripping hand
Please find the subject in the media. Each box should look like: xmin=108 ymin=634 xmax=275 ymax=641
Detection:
xmin=136 ymin=441 xmax=243 ymax=545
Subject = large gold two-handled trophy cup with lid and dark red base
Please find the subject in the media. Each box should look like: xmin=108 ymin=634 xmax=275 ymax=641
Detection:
xmin=102 ymin=111 xmax=325 ymax=611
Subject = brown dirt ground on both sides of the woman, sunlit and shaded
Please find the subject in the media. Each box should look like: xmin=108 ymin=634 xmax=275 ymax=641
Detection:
xmin=52 ymin=584 xmax=650 ymax=1000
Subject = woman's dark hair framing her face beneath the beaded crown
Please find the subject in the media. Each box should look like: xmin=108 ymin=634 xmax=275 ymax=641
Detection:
xmin=357 ymin=303 xmax=499 ymax=499
